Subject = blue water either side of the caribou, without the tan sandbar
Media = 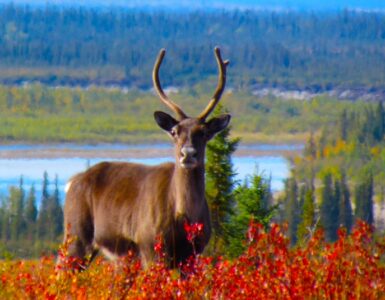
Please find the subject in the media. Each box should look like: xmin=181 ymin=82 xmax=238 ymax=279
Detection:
xmin=0 ymin=144 xmax=292 ymax=202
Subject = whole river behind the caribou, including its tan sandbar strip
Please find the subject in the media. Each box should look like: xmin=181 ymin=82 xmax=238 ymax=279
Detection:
xmin=0 ymin=144 xmax=302 ymax=204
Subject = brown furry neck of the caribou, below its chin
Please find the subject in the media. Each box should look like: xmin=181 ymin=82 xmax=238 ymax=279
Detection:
xmin=172 ymin=165 xmax=205 ymax=223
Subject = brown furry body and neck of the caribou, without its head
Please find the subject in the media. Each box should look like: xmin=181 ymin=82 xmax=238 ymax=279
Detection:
xmin=64 ymin=141 xmax=211 ymax=266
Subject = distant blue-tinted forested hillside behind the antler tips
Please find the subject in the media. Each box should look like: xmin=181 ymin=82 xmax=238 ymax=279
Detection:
xmin=0 ymin=4 xmax=385 ymax=90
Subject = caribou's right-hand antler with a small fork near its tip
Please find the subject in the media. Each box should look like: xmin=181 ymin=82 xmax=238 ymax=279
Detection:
xmin=198 ymin=47 xmax=230 ymax=121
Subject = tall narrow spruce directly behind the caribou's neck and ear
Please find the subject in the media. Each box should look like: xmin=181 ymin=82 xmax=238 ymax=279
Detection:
xmin=206 ymin=105 xmax=239 ymax=253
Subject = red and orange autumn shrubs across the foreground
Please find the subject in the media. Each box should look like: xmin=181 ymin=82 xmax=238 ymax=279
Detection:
xmin=0 ymin=222 xmax=385 ymax=299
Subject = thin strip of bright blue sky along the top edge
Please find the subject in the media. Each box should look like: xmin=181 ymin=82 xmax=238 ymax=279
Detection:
xmin=0 ymin=0 xmax=385 ymax=10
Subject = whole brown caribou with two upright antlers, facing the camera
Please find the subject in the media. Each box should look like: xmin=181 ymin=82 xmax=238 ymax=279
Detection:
xmin=59 ymin=47 xmax=231 ymax=269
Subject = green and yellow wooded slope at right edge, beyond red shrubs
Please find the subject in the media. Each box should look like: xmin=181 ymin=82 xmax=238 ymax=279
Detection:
xmin=280 ymin=102 xmax=385 ymax=244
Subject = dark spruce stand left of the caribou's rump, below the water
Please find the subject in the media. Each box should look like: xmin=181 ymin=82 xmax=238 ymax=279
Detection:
xmin=0 ymin=172 xmax=63 ymax=259
